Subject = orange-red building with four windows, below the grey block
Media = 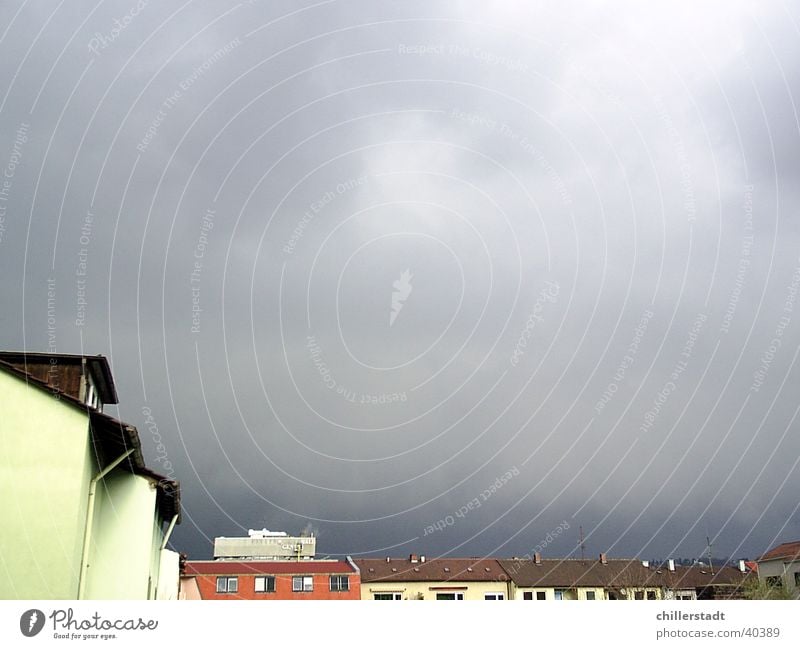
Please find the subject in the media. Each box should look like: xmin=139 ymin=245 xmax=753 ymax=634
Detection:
xmin=181 ymin=557 xmax=361 ymax=599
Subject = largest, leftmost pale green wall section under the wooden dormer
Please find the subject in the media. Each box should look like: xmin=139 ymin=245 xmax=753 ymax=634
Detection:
xmin=0 ymin=371 xmax=95 ymax=599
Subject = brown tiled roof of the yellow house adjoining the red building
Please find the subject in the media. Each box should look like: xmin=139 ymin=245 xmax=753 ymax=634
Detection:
xmin=354 ymin=557 xmax=508 ymax=584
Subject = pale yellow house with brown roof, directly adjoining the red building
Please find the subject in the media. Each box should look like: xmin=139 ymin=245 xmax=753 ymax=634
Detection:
xmin=355 ymin=554 xmax=511 ymax=601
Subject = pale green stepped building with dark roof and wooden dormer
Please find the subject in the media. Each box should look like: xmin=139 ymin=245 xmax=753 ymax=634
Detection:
xmin=0 ymin=352 xmax=180 ymax=599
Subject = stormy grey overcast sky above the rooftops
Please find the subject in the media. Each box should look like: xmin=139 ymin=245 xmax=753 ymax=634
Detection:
xmin=0 ymin=0 xmax=800 ymax=558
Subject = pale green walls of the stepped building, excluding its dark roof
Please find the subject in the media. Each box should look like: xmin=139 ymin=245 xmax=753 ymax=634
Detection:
xmin=0 ymin=371 xmax=178 ymax=599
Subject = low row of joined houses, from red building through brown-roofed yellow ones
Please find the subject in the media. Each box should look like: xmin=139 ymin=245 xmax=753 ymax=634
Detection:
xmin=181 ymin=536 xmax=757 ymax=601
